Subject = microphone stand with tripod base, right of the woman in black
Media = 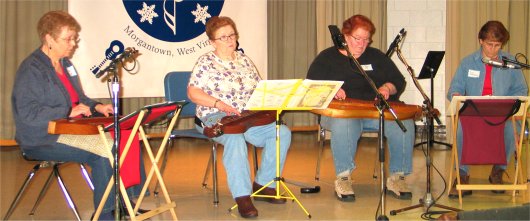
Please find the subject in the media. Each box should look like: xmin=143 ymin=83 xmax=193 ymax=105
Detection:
xmin=390 ymin=46 xmax=461 ymax=216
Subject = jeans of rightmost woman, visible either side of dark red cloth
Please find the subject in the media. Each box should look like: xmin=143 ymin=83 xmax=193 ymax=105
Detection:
xmin=456 ymin=119 xmax=521 ymax=175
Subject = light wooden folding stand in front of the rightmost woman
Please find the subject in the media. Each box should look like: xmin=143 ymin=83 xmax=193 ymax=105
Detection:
xmin=447 ymin=96 xmax=528 ymax=206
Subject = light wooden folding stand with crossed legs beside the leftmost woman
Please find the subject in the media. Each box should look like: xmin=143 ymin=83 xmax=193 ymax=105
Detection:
xmin=94 ymin=102 xmax=183 ymax=220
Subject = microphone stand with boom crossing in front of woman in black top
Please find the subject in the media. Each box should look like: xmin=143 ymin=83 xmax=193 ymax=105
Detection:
xmin=344 ymin=46 xmax=407 ymax=220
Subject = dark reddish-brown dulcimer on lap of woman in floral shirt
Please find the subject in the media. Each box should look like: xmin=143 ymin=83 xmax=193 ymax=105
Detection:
xmin=203 ymin=111 xmax=276 ymax=138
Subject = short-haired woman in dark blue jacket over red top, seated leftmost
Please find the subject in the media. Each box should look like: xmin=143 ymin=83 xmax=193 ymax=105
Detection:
xmin=11 ymin=11 xmax=145 ymax=220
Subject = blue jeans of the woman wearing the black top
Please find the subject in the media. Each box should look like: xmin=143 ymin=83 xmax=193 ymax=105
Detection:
xmin=320 ymin=116 xmax=415 ymax=175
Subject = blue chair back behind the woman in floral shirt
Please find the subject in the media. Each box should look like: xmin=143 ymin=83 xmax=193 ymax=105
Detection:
xmin=164 ymin=71 xmax=197 ymax=118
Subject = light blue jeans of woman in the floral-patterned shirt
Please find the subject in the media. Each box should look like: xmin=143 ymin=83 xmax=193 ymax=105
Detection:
xmin=196 ymin=121 xmax=291 ymax=198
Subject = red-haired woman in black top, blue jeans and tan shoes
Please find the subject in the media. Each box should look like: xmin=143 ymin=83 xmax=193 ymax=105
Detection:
xmin=307 ymin=15 xmax=414 ymax=201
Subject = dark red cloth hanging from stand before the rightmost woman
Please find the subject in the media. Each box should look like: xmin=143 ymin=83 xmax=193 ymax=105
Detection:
xmin=459 ymin=99 xmax=520 ymax=165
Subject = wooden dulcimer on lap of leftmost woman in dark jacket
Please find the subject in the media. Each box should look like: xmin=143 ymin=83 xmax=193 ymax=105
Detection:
xmin=48 ymin=117 xmax=114 ymax=135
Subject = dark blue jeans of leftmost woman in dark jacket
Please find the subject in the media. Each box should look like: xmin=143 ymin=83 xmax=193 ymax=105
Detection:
xmin=21 ymin=143 xmax=148 ymax=213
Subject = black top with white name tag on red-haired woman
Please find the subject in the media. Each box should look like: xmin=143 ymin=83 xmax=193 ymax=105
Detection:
xmin=307 ymin=47 xmax=406 ymax=101
